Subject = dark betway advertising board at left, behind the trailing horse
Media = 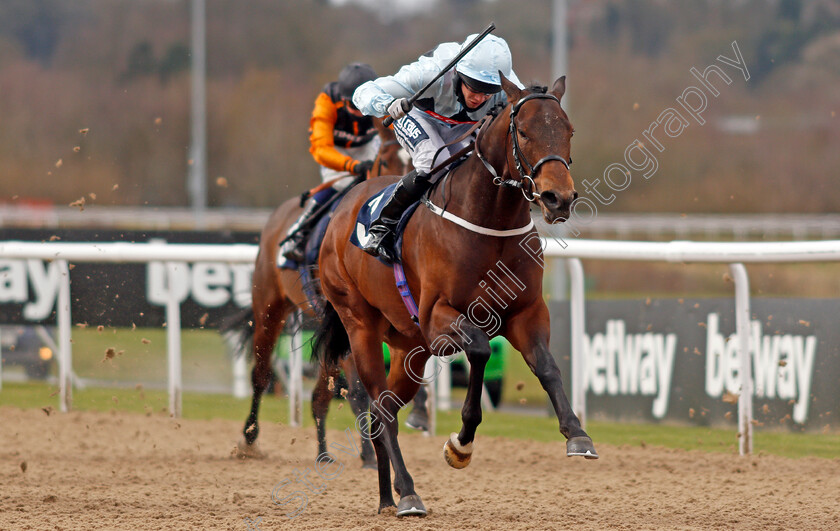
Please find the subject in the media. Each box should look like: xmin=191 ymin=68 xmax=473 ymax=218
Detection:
xmin=0 ymin=228 xmax=259 ymax=328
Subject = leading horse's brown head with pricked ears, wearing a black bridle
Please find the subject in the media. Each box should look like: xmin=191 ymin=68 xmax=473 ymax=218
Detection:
xmin=501 ymin=75 xmax=578 ymax=223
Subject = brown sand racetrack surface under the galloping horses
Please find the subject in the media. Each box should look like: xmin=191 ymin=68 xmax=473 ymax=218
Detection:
xmin=0 ymin=407 xmax=840 ymax=531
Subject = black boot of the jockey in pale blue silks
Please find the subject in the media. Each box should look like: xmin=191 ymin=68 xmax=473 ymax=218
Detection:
xmin=362 ymin=170 xmax=432 ymax=263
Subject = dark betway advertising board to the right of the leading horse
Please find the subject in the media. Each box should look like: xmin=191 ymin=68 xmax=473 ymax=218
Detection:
xmin=551 ymin=298 xmax=840 ymax=430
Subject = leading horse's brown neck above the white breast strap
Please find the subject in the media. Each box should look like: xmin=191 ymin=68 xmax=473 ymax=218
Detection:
xmin=433 ymin=132 xmax=530 ymax=230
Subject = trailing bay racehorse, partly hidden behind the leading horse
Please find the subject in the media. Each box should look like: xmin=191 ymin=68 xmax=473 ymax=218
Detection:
xmin=226 ymin=119 xmax=405 ymax=468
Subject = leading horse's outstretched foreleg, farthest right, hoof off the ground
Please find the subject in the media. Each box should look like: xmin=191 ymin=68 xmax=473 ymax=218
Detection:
xmin=506 ymin=305 xmax=598 ymax=459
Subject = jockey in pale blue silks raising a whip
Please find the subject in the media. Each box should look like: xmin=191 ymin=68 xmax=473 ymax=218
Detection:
xmin=353 ymin=35 xmax=523 ymax=262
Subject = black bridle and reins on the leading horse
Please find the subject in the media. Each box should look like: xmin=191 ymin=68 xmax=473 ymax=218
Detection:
xmin=475 ymin=92 xmax=572 ymax=202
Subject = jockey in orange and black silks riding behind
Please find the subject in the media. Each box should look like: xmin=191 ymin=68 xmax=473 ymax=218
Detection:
xmin=280 ymin=63 xmax=381 ymax=262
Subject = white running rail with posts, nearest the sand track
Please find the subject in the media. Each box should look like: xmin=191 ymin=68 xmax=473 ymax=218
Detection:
xmin=0 ymin=239 xmax=840 ymax=454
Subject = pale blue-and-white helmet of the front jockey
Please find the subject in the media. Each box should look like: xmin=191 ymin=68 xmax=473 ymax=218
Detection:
xmin=455 ymin=34 xmax=512 ymax=94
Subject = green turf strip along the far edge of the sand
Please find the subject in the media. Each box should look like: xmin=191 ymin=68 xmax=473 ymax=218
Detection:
xmin=0 ymin=382 xmax=840 ymax=459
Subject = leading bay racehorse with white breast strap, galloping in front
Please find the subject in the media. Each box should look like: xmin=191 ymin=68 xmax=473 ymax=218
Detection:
xmin=314 ymin=76 xmax=598 ymax=516
